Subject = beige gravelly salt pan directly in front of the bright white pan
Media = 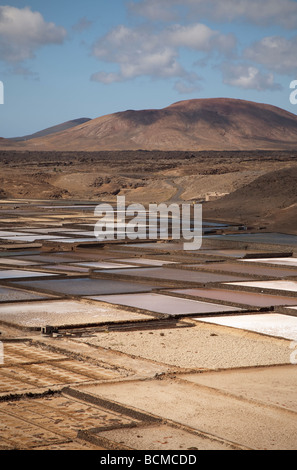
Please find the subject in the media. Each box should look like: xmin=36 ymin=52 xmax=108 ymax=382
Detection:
xmin=75 ymin=323 xmax=292 ymax=369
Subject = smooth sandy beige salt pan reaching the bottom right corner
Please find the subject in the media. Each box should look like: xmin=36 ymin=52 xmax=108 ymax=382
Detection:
xmin=78 ymin=370 xmax=296 ymax=450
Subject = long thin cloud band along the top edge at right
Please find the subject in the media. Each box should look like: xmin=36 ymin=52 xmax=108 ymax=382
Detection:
xmin=129 ymin=0 xmax=297 ymax=29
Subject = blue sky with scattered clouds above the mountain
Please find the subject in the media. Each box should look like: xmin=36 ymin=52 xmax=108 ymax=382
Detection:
xmin=0 ymin=0 xmax=297 ymax=137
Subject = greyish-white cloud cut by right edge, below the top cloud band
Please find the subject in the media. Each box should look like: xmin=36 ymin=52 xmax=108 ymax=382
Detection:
xmin=244 ymin=36 xmax=297 ymax=75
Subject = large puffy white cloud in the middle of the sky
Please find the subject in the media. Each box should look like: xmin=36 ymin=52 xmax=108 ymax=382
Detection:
xmin=91 ymin=23 xmax=235 ymax=90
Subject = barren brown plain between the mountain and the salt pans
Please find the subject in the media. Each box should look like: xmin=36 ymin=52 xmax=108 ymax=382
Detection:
xmin=0 ymin=150 xmax=297 ymax=233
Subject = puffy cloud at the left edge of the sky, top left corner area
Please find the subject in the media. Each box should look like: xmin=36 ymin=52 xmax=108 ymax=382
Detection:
xmin=0 ymin=6 xmax=67 ymax=63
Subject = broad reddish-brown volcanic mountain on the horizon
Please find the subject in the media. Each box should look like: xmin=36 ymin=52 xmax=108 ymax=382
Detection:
xmin=0 ymin=98 xmax=297 ymax=151
